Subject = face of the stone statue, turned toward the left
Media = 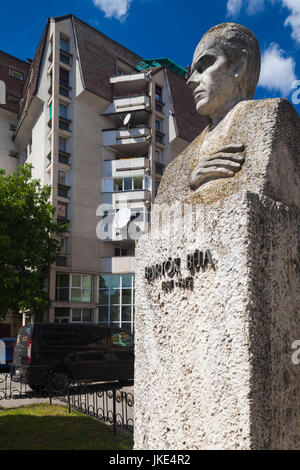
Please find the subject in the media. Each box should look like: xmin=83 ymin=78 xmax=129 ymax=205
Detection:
xmin=187 ymin=40 xmax=237 ymax=119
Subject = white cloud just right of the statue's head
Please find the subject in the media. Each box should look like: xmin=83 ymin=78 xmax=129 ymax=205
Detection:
xmin=258 ymin=43 xmax=296 ymax=96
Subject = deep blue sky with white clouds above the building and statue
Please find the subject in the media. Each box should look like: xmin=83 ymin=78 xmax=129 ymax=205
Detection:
xmin=0 ymin=0 xmax=300 ymax=113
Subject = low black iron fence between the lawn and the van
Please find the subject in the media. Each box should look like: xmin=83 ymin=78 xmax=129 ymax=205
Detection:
xmin=0 ymin=373 xmax=134 ymax=433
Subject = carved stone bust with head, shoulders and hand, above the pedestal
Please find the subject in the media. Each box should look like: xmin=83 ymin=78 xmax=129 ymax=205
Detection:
xmin=155 ymin=23 xmax=300 ymax=208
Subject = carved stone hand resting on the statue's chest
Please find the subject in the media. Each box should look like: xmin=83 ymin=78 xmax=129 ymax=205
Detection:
xmin=189 ymin=144 xmax=245 ymax=189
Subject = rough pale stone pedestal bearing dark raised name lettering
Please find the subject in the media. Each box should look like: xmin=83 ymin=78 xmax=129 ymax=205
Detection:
xmin=135 ymin=97 xmax=300 ymax=450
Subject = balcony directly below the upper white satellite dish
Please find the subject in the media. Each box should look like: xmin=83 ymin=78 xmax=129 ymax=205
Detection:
xmin=102 ymin=126 xmax=151 ymax=156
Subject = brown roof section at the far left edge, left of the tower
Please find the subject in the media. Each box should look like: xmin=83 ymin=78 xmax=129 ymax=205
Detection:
xmin=0 ymin=51 xmax=30 ymax=113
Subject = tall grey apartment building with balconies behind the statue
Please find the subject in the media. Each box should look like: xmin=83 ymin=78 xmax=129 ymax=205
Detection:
xmin=0 ymin=15 xmax=206 ymax=335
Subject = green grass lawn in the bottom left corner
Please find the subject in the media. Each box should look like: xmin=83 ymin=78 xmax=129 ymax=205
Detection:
xmin=0 ymin=404 xmax=133 ymax=450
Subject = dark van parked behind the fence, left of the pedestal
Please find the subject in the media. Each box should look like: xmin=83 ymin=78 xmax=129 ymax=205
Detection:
xmin=11 ymin=323 xmax=134 ymax=389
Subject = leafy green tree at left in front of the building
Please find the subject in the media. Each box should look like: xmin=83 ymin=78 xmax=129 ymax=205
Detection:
xmin=0 ymin=164 xmax=66 ymax=318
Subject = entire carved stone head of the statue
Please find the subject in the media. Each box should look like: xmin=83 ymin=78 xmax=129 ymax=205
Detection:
xmin=187 ymin=23 xmax=260 ymax=126
